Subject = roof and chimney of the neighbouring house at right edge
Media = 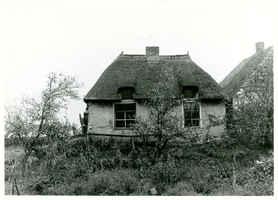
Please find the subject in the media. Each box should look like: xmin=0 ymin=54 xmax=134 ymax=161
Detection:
xmin=219 ymin=42 xmax=273 ymax=101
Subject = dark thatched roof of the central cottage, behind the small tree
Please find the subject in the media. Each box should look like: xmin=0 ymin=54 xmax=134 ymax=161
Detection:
xmin=84 ymin=49 xmax=224 ymax=102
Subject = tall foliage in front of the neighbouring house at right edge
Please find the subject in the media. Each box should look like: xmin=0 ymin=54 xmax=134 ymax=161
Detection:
xmin=227 ymin=50 xmax=274 ymax=147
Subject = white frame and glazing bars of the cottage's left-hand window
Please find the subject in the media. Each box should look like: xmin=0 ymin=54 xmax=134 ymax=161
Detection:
xmin=113 ymin=100 xmax=137 ymax=130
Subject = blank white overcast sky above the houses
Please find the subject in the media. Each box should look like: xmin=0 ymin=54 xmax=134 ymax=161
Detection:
xmin=0 ymin=0 xmax=278 ymax=124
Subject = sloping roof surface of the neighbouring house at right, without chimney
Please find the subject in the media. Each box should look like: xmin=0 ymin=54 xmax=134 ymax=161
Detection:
xmin=220 ymin=46 xmax=273 ymax=99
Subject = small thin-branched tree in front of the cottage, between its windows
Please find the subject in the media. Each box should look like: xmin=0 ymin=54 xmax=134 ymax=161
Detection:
xmin=135 ymin=67 xmax=197 ymax=164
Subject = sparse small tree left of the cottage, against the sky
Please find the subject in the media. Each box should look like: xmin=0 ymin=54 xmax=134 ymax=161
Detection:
xmin=5 ymin=72 xmax=82 ymax=176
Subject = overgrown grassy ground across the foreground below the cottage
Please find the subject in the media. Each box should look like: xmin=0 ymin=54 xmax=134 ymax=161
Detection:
xmin=5 ymin=140 xmax=273 ymax=196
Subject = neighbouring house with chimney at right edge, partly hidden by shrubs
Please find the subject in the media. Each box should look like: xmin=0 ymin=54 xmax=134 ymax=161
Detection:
xmin=220 ymin=42 xmax=274 ymax=144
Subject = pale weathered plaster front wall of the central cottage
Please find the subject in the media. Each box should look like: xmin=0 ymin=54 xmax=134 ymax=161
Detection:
xmin=88 ymin=99 xmax=226 ymax=137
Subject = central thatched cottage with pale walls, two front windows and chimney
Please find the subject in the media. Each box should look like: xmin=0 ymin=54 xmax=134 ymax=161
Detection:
xmin=84 ymin=47 xmax=226 ymax=139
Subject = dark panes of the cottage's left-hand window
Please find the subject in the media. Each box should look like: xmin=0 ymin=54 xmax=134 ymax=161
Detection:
xmin=114 ymin=103 xmax=136 ymax=128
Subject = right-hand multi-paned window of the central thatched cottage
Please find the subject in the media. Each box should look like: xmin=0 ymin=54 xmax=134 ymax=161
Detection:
xmin=183 ymin=102 xmax=200 ymax=126
